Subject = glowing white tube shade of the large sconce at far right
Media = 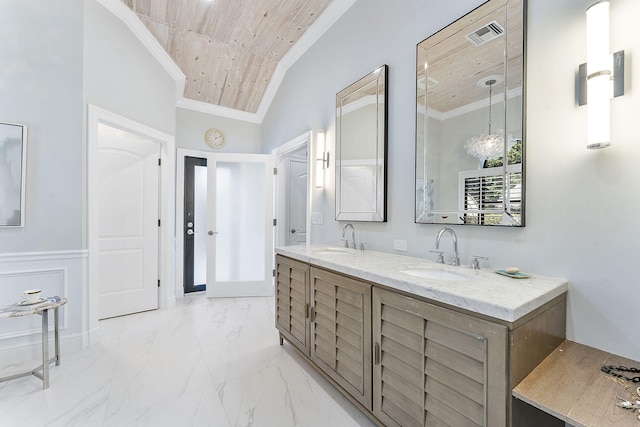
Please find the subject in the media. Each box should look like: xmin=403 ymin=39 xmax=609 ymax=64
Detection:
xmin=586 ymin=1 xmax=613 ymax=148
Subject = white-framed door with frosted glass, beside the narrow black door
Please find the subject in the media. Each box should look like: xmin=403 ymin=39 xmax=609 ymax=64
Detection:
xmin=207 ymin=154 xmax=273 ymax=297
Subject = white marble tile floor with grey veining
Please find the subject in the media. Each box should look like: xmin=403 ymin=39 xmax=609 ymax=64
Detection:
xmin=0 ymin=293 xmax=374 ymax=427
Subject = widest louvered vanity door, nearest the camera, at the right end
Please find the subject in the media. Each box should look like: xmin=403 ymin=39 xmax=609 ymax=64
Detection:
xmin=373 ymin=288 xmax=510 ymax=427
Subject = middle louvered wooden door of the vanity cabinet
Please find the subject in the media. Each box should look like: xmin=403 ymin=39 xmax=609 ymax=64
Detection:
xmin=310 ymin=267 xmax=372 ymax=410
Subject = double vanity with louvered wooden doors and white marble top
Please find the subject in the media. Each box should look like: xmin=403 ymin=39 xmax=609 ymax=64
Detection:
xmin=276 ymin=246 xmax=567 ymax=426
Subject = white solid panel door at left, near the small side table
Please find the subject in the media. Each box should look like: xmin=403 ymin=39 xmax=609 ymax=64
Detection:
xmin=97 ymin=124 xmax=160 ymax=319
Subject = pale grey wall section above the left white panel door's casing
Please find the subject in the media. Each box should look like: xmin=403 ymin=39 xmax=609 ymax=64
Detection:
xmin=84 ymin=0 xmax=176 ymax=135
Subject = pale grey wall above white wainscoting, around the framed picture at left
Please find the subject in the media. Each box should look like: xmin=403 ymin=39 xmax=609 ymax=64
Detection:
xmin=0 ymin=0 xmax=84 ymax=253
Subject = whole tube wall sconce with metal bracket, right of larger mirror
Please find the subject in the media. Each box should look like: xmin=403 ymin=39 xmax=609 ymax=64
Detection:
xmin=578 ymin=1 xmax=624 ymax=149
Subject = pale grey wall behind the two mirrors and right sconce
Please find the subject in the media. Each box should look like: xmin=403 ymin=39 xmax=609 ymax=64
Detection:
xmin=262 ymin=0 xmax=640 ymax=359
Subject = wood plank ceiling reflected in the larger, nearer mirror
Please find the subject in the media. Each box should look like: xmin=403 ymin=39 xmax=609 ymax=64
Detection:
xmin=418 ymin=0 xmax=523 ymax=113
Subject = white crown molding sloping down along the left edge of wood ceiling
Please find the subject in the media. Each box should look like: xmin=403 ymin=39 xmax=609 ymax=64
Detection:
xmin=96 ymin=0 xmax=187 ymax=99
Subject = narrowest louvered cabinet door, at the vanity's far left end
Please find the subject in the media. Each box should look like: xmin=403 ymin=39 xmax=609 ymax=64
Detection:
xmin=275 ymin=255 xmax=310 ymax=355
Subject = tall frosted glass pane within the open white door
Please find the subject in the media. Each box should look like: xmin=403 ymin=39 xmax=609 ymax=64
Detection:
xmin=215 ymin=162 xmax=268 ymax=282
